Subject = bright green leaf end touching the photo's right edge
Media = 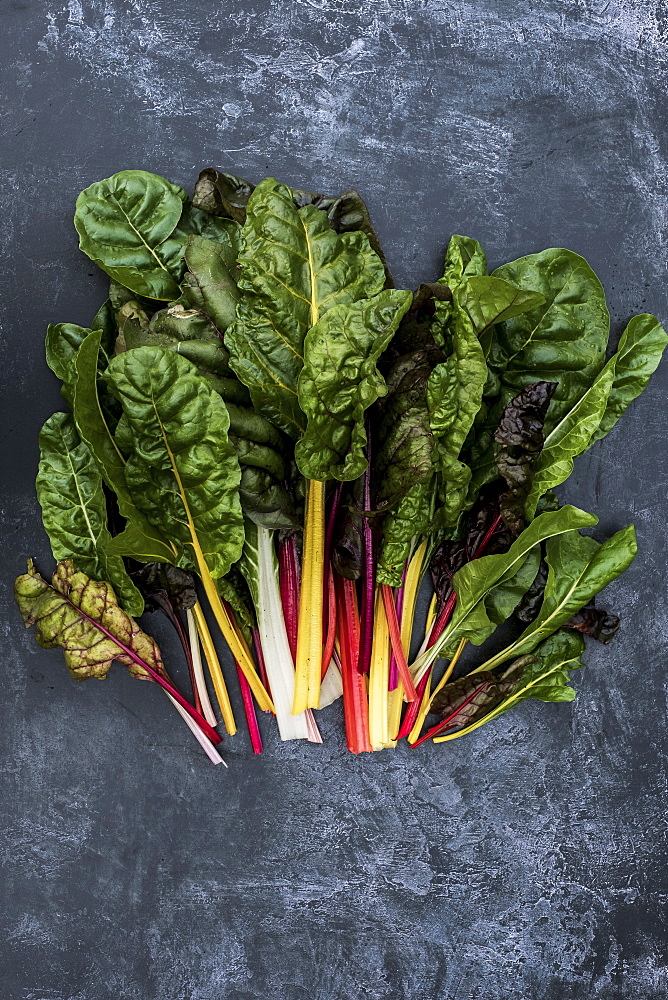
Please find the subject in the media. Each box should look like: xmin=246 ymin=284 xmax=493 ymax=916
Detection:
xmin=590 ymin=313 xmax=668 ymax=445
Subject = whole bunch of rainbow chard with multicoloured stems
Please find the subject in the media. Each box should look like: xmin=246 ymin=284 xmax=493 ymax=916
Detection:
xmin=16 ymin=169 xmax=668 ymax=763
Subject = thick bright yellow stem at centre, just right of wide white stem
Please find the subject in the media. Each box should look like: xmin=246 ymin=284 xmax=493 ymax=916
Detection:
xmin=292 ymin=479 xmax=325 ymax=715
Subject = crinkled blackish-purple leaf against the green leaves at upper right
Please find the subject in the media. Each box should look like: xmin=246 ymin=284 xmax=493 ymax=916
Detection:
xmin=494 ymin=382 xmax=557 ymax=537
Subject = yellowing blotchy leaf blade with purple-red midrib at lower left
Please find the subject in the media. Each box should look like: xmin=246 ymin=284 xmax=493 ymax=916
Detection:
xmin=14 ymin=559 xmax=166 ymax=681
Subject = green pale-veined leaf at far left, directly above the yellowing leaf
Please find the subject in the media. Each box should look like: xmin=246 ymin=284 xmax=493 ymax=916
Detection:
xmin=37 ymin=408 xmax=144 ymax=615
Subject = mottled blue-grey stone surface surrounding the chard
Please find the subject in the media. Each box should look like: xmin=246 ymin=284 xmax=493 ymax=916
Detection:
xmin=0 ymin=0 xmax=668 ymax=1000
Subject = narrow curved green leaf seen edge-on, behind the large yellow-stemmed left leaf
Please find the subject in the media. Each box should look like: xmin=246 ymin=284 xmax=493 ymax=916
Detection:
xmin=73 ymin=330 xmax=175 ymax=575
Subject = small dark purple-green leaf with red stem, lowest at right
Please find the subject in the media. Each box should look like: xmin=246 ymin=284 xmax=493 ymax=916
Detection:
xmin=431 ymin=656 xmax=533 ymax=727
